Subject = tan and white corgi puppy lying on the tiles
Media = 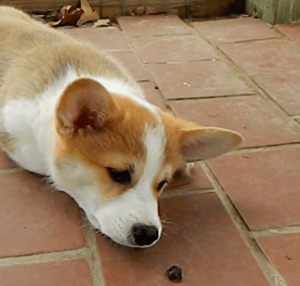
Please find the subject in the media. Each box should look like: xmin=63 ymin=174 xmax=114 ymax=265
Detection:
xmin=0 ymin=6 xmax=243 ymax=248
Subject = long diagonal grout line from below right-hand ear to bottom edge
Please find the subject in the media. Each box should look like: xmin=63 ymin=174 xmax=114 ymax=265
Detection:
xmin=200 ymin=162 xmax=287 ymax=286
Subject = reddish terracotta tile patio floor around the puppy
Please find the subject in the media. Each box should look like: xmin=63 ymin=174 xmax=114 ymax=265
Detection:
xmin=0 ymin=13 xmax=300 ymax=286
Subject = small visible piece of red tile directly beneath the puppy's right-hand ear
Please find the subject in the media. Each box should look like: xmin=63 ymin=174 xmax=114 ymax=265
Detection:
xmin=164 ymin=163 xmax=212 ymax=192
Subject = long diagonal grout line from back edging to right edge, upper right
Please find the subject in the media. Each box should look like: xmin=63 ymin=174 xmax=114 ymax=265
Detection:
xmin=191 ymin=25 xmax=300 ymax=132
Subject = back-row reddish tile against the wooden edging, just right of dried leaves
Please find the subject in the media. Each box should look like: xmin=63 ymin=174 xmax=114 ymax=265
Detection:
xmin=118 ymin=15 xmax=193 ymax=37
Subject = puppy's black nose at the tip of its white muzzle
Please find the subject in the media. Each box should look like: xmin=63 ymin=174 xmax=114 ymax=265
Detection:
xmin=131 ymin=224 xmax=158 ymax=246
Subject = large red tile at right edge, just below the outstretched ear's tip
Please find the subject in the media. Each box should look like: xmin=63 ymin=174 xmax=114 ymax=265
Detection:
xmin=208 ymin=148 xmax=300 ymax=229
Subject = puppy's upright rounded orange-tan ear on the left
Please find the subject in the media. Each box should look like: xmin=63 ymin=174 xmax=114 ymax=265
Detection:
xmin=56 ymin=78 xmax=117 ymax=137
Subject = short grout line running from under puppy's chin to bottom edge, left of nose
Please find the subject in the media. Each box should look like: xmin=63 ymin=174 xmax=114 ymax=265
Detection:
xmin=82 ymin=217 xmax=105 ymax=286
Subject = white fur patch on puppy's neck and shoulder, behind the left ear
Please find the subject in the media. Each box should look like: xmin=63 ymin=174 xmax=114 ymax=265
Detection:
xmin=2 ymin=69 xmax=76 ymax=176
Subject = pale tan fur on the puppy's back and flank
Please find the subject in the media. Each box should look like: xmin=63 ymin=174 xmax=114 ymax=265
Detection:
xmin=0 ymin=6 xmax=136 ymax=152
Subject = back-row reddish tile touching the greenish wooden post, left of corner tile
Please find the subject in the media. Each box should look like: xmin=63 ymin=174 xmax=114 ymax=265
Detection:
xmin=193 ymin=17 xmax=281 ymax=45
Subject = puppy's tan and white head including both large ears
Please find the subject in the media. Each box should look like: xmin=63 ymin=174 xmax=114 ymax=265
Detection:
xmin=53 ymin=79 xmax=242 ymax=247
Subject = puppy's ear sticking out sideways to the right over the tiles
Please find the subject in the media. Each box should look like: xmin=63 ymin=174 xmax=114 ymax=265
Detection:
xmin=179 ymin=124 xmax=243 ymax=162
